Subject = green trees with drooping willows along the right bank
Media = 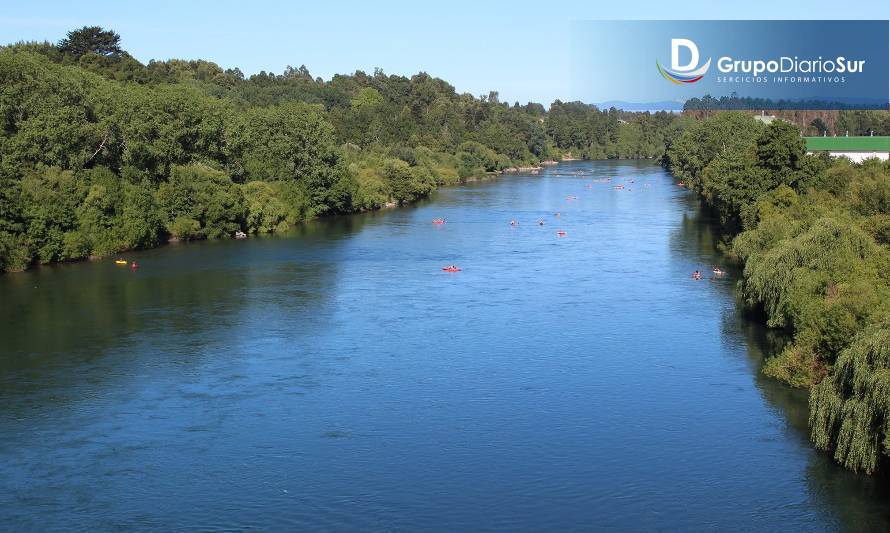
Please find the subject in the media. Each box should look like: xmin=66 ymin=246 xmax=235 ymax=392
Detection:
xmin=665 ymin=111 xmax=890 ymax=475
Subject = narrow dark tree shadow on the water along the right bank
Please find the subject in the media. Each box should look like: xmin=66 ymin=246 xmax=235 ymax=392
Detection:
xmin=671 ymin=181 xmax=890 ymax=531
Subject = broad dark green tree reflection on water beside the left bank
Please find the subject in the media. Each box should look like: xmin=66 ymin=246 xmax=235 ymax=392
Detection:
xmin=0 ymin=210 xmax=374 ymax=419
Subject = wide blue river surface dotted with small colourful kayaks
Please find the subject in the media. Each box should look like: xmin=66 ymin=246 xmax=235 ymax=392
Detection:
xmin=0 ymin=162 xmax=890 ymax=531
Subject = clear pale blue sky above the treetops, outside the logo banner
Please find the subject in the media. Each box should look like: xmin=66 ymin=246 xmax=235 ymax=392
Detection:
xmin=0 ymin=0 xmax=890 ymax=103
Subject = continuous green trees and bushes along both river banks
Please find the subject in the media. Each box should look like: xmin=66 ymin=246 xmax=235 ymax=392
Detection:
xmin=0 ymin=27 xmax=890 ymax=474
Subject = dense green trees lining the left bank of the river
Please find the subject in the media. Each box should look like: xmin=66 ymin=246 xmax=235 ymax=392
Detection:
xmin=0 ymin=27 xmax=682 ymax=273
